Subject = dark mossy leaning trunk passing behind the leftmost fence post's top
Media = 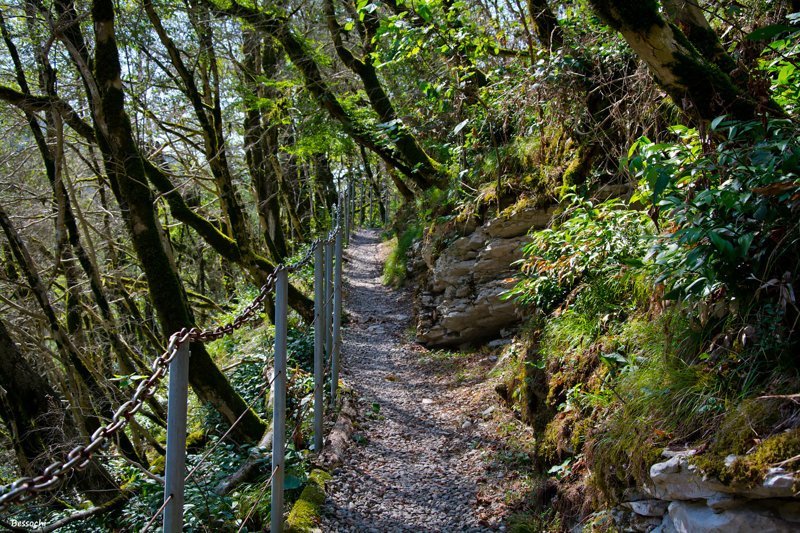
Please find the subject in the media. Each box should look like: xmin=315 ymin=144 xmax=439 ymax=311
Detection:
xmin=92 ymin=0 xmax=266 ymax=442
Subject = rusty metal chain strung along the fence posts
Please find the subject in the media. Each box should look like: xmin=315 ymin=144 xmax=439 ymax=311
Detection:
xmin=0 ymin=196 xmax=343 ymax=511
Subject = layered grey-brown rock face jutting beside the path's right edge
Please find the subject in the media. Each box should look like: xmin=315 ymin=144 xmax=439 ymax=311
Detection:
xmin=411 ymin=207 xmax=553 ymax=346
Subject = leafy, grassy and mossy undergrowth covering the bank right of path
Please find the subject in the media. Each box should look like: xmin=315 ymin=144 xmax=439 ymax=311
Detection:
xmin=496 ymin=114 xmax=800 ymax=523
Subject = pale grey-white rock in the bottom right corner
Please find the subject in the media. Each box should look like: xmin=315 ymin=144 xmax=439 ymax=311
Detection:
xmin=613 ymin=450 xmax=800 ymax=533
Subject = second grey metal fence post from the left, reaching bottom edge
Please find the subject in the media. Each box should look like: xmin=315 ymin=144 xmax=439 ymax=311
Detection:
xmin=270 ymin=268 xmax=289 ymax=533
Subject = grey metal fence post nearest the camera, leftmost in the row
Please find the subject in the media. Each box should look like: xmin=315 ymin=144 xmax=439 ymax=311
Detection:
xmin=164 ymin=341 xmax=189 ymax=533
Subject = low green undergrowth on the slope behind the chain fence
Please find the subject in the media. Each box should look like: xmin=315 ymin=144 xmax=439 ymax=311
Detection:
xmin=2 ymin=287 xmax=324 ymax=532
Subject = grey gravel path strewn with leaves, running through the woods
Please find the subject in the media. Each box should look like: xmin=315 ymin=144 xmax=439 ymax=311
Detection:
xmin=322 ymin=231 xmax=505 ymax=533
